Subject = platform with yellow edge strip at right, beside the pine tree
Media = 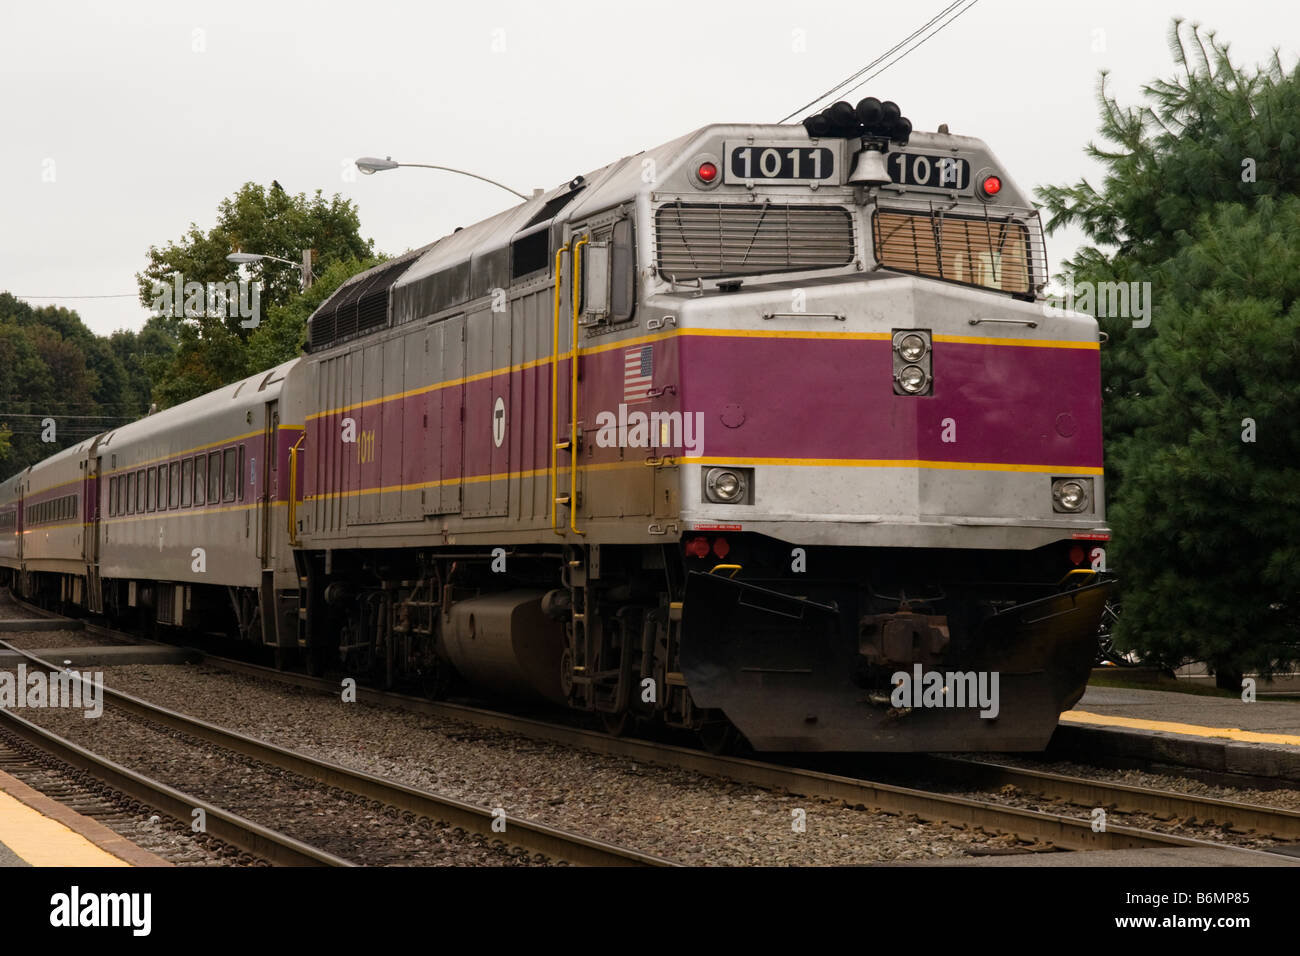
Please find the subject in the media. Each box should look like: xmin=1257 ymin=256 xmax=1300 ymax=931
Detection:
xmin=1049 ymin=687 xmax=1300 ymax=786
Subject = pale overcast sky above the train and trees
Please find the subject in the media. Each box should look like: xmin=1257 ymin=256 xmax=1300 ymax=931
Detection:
xmin=0 ymin=0 xmax=1300 ymax=333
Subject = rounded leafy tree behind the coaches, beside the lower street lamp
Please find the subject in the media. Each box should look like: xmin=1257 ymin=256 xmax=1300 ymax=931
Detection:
xmin=137 ymin=182 xmax=373 ymax=407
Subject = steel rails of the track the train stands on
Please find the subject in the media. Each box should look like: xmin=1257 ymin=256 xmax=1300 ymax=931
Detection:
xmin=5 ymin=595 xmax=1300 ymax=862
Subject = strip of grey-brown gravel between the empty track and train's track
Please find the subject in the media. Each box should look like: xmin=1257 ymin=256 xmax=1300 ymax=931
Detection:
xmin=58 ymin=665 xmax=1026 ymax=866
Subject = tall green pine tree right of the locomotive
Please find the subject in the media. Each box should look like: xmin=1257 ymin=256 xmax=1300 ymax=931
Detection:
xmin=1037 ymin=20 xmax=1300 ymax=687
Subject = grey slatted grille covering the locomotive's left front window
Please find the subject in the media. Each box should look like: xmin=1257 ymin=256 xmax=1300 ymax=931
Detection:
xmin=655 ymin=203 xmax=855 ymax=278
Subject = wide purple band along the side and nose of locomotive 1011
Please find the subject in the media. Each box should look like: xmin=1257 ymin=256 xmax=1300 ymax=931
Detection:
xmin=302 ymin=336 xmax=1101 ymax=496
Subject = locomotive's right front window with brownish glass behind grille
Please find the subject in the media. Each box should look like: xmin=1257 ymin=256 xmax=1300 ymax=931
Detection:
xmin=871 ymin=207 xmax=1047 ymax=295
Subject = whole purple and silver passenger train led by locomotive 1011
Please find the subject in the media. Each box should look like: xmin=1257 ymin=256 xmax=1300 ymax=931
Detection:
xmin=0 ymin=98 xmax=1109 ymax=750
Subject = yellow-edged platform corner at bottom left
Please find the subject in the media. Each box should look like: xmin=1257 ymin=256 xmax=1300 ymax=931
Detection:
xmin=0 ymin=771 xmax=172 ymax=866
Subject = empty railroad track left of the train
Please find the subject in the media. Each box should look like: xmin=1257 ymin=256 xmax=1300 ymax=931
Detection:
xmin=0 ymin=613 xmax=671 ymax=866
